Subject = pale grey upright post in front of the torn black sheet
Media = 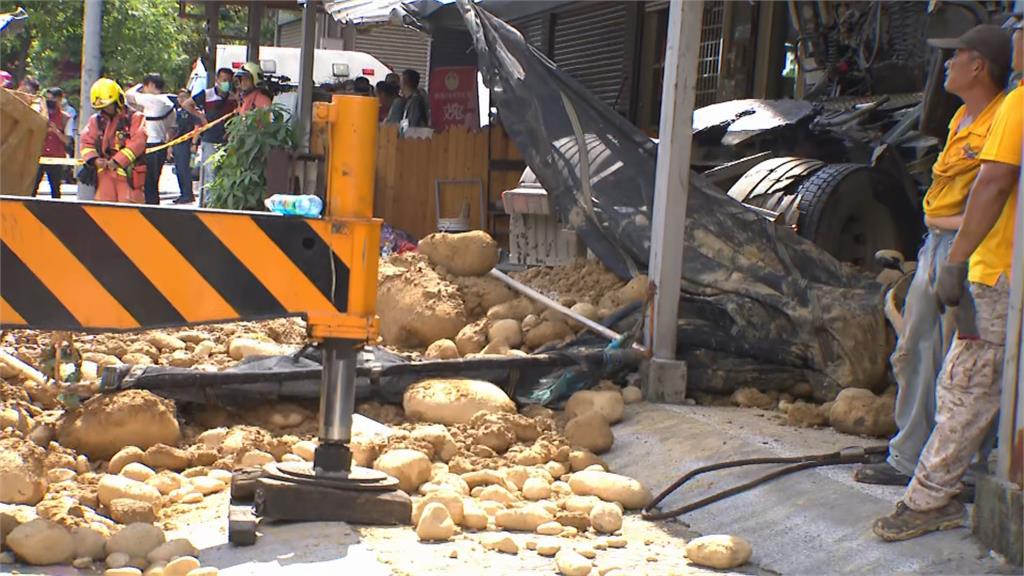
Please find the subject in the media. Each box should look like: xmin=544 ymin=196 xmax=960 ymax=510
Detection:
xmin=645 ymin=1 xmax=703 ymax=402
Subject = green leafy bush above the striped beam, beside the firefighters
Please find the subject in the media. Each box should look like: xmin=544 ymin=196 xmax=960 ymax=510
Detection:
xmin=208 ymin=105 xmax=295 ymax=210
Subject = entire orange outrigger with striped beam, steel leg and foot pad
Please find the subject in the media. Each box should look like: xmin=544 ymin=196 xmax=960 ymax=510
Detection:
xmin=0 ymin=95 xmax=411 ymax=544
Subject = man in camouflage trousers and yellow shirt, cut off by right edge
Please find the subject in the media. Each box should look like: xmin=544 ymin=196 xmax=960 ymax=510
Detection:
xmin=874 ymin=19 xmax=1024 ymax=540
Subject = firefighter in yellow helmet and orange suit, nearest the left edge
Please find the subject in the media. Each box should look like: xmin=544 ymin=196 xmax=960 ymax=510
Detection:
xmin=82 ymin=78 xmax=146 ymax=204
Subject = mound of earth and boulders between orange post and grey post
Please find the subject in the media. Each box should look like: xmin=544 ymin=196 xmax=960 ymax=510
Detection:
xmin=377 ymin=231 xmax=647 ymax=359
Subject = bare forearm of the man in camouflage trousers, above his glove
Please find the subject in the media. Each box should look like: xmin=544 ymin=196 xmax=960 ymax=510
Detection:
xmin=948 ymin=162 xmax=1018 ymax=262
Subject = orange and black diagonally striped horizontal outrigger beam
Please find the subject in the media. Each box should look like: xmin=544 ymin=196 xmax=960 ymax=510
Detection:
xmin=0 ymin=197 xmax=380 ymax=340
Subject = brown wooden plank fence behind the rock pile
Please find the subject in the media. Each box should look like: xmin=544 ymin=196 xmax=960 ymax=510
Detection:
xmin=374 ymin=124 xmax=525 ymax=241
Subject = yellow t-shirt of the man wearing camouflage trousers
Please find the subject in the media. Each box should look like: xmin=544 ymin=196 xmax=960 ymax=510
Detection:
xmin=968 ymin=85 xmax=1024 ymax=286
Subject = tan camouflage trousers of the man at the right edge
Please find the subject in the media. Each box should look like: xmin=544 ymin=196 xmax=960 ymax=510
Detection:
xmin=903 ymin=277 xmax=1010 ymax=511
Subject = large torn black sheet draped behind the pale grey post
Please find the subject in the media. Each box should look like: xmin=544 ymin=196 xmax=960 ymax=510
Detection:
xmin=459 ymin=0 xmax=891 ymax=393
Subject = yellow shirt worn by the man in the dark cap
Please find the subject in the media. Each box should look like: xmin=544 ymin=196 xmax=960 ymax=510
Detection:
xmin=925 ymin=94 xmax=1004 ymax=216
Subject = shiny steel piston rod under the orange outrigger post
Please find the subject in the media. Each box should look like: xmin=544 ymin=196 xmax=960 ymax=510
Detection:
xmin=319 ymin=338 xmax=357 ymax=444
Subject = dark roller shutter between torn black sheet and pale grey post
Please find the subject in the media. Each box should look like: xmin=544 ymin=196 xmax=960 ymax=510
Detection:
xmin=551 ymin=2 xmax=628 ymax=111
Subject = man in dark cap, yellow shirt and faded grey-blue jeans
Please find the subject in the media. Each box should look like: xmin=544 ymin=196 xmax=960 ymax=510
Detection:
xmin=853 ymin=26 xmax=1010 ymax=486
